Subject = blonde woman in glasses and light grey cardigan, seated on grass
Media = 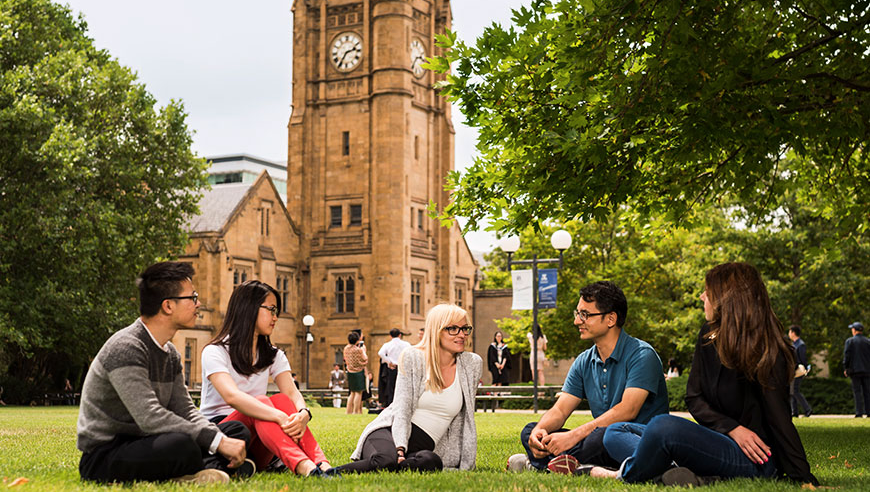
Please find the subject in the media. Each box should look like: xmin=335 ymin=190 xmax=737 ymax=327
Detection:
xmin=339 ymin=304 xmax=483 ymax=473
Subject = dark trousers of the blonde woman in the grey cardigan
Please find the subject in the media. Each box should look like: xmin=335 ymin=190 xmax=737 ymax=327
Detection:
xmin=338 ymin=424 xmax=444 ymax=473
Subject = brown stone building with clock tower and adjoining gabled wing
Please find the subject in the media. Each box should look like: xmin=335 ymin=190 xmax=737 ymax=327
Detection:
xmin=176 ymin=0 xmax=477 ymax=388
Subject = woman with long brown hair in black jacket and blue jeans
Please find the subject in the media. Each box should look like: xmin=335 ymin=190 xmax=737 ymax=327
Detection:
xmin=591 ymin=263 xmax=818 ymax=485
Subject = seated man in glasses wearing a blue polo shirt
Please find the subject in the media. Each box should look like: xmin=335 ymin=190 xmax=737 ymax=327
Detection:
xmin=508 ymin=281 xmax=668 ymax=473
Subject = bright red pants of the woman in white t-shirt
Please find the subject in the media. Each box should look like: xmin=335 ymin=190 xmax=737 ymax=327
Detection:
xmin=222 ymin=393 xmax=327 ymax=472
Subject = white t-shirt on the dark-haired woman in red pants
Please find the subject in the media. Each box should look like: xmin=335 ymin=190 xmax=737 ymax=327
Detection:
xmin=199 ymin=345 xmax=290 ymax=419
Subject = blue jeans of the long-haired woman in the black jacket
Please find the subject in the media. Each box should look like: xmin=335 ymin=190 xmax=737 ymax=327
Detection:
xmin=605 ymin=415 xmax=776 ymax=483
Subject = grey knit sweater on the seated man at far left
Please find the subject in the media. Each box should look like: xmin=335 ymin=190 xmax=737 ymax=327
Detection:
xmin=76 ymin=319 xmax=218 ymax=452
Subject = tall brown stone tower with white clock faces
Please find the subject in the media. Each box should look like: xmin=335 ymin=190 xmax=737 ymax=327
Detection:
xmin=287 ymin=0 xmax=477 ymax=387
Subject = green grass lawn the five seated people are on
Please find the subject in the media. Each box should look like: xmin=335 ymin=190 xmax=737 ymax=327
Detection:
xmin=0 ymin=407 xmax=870 ymax=492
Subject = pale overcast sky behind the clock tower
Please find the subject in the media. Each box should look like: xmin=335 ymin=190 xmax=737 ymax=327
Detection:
xmin=60 ymin=0 xmax=531 ymax=251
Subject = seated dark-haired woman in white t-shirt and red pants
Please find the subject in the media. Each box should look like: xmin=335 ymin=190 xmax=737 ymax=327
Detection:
xmin=200 ymin=280 xmax=335 ymax=476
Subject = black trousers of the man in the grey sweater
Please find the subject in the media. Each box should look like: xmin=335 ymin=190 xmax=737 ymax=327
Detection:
xmin=79 ymin=422 xmax=251 ymax=482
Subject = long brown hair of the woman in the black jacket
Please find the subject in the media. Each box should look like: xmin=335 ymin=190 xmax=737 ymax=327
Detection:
xmin=705 ymin=263 xmax=794 ymax=387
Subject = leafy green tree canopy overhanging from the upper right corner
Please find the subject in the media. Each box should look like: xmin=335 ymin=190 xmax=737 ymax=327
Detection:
xmin=429 ymin=0 xmax=870 ymax=234
